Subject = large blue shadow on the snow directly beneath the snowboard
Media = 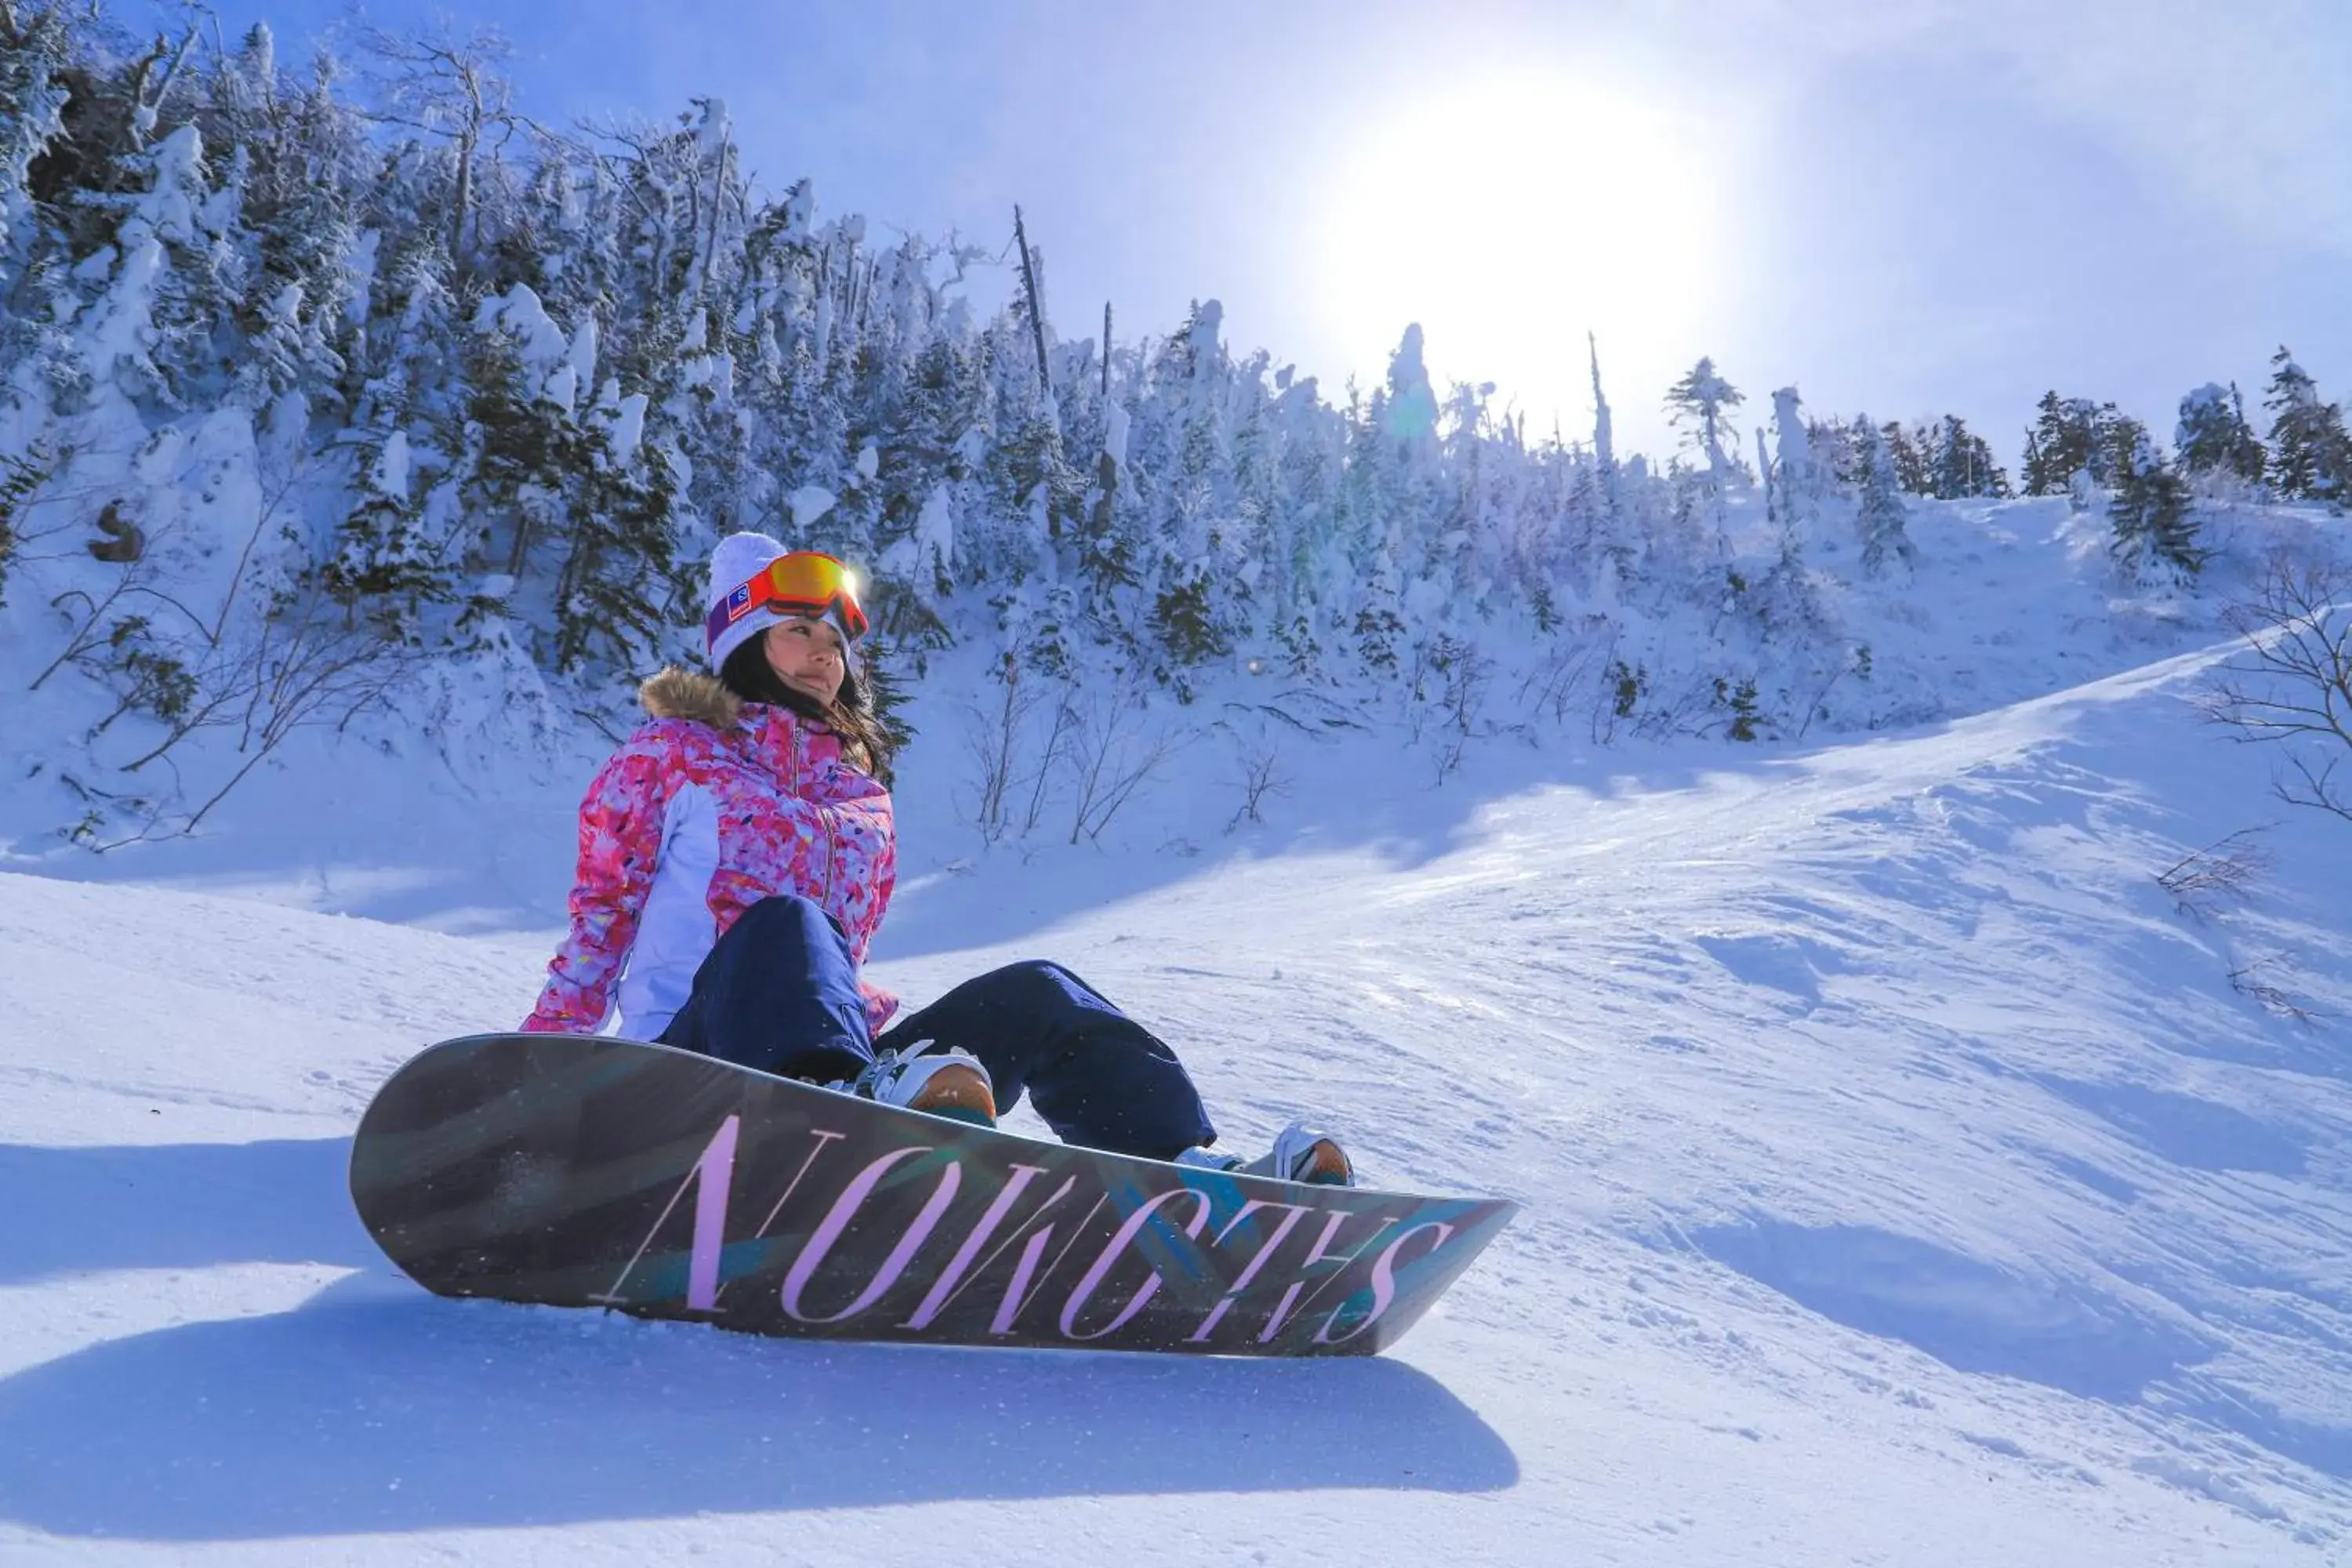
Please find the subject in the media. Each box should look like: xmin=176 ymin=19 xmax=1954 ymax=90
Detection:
xmin=0 ymin=1272 xmax=1519 ymax=1542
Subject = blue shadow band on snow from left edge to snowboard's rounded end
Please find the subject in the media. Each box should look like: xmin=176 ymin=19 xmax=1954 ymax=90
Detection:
xmin=0 ymin=1138 xmax=379 ymax=1286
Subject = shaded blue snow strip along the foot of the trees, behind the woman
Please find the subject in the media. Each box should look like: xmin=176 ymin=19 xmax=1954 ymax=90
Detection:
xmin=18 ymin=703 xmax=1759 ymax=959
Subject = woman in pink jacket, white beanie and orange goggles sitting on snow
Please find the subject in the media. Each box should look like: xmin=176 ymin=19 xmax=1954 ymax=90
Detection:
xmin=522 ymin=534 xmax=1352 ymax=1182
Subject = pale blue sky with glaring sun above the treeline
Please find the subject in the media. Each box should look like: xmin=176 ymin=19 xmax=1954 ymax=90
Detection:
xmin=142 ymin=0 xmax=2352 ymax=461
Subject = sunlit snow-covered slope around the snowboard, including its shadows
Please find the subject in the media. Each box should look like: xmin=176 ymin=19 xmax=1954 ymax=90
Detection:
xmin=0 ymin=620 xmax=2352 ymax=1566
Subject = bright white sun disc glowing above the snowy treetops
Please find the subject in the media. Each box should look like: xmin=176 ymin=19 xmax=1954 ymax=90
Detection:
xmin=1317 ymin=71 xmax=1726 ymax=430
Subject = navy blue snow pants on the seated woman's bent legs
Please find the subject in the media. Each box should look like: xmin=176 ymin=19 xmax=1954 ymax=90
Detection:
xmin=661 ymin=895 xmax=1216 ymax=1159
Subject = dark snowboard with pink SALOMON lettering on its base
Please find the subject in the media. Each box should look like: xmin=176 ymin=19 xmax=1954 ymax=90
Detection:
xmin=350 ymin=1034 xmax=1517 ymax=1356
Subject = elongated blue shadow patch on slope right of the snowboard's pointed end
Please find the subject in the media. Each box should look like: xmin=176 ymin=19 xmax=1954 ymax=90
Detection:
xmin=1693 ymin=1220 xmax=2211 ymax=1403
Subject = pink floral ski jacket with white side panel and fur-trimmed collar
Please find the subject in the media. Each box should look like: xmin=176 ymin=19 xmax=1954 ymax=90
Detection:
xmin=522 ymin=670 xmax=898 ymax=1039
